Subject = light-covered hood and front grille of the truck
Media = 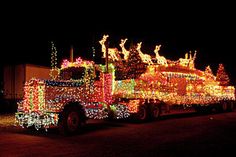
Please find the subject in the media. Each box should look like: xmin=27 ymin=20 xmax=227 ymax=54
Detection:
xmin=18 ymin=78 xmax=84 ymax=112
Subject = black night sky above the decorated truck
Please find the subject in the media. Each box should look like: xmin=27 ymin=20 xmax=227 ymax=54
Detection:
xmin=1 ymin=2 xmax=236 ymax=84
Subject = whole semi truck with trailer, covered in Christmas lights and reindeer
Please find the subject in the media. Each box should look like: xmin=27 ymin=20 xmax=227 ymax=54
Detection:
xmin=15 ymin=35 xmax=235 ymax=134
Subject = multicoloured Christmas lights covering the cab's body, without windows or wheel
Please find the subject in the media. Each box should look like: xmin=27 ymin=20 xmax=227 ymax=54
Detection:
xmin=16 ymin=58 xmax=118 ymax=129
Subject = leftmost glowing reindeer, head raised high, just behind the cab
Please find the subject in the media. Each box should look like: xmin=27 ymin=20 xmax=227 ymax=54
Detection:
xmin=99 ymin=35 xmax=119 ymax=61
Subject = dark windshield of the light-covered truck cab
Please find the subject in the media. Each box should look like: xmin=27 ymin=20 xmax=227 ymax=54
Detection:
xmin=60 ymin=67 xmax=85 ymax=80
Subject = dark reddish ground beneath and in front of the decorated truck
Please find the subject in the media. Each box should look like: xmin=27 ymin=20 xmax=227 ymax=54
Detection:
xmin=0 ymin=111 xmax=236 ymax=157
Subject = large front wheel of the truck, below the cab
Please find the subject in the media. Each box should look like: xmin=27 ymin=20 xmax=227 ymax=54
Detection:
xmin=59 ymin=106 xmax=82 ymax=134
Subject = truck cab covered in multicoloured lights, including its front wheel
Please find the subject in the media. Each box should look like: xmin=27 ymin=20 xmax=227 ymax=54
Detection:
xmin=16 ymin=58 xmax=128 ymax=133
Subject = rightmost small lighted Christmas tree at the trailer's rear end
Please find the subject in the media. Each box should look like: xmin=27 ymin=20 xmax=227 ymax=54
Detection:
xmin=216 ymin=64 xmax=230 ymax=86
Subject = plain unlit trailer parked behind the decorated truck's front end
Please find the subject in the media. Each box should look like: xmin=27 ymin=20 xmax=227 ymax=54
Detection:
xmin=0 ymin=64 xmax=51 ymax=112
